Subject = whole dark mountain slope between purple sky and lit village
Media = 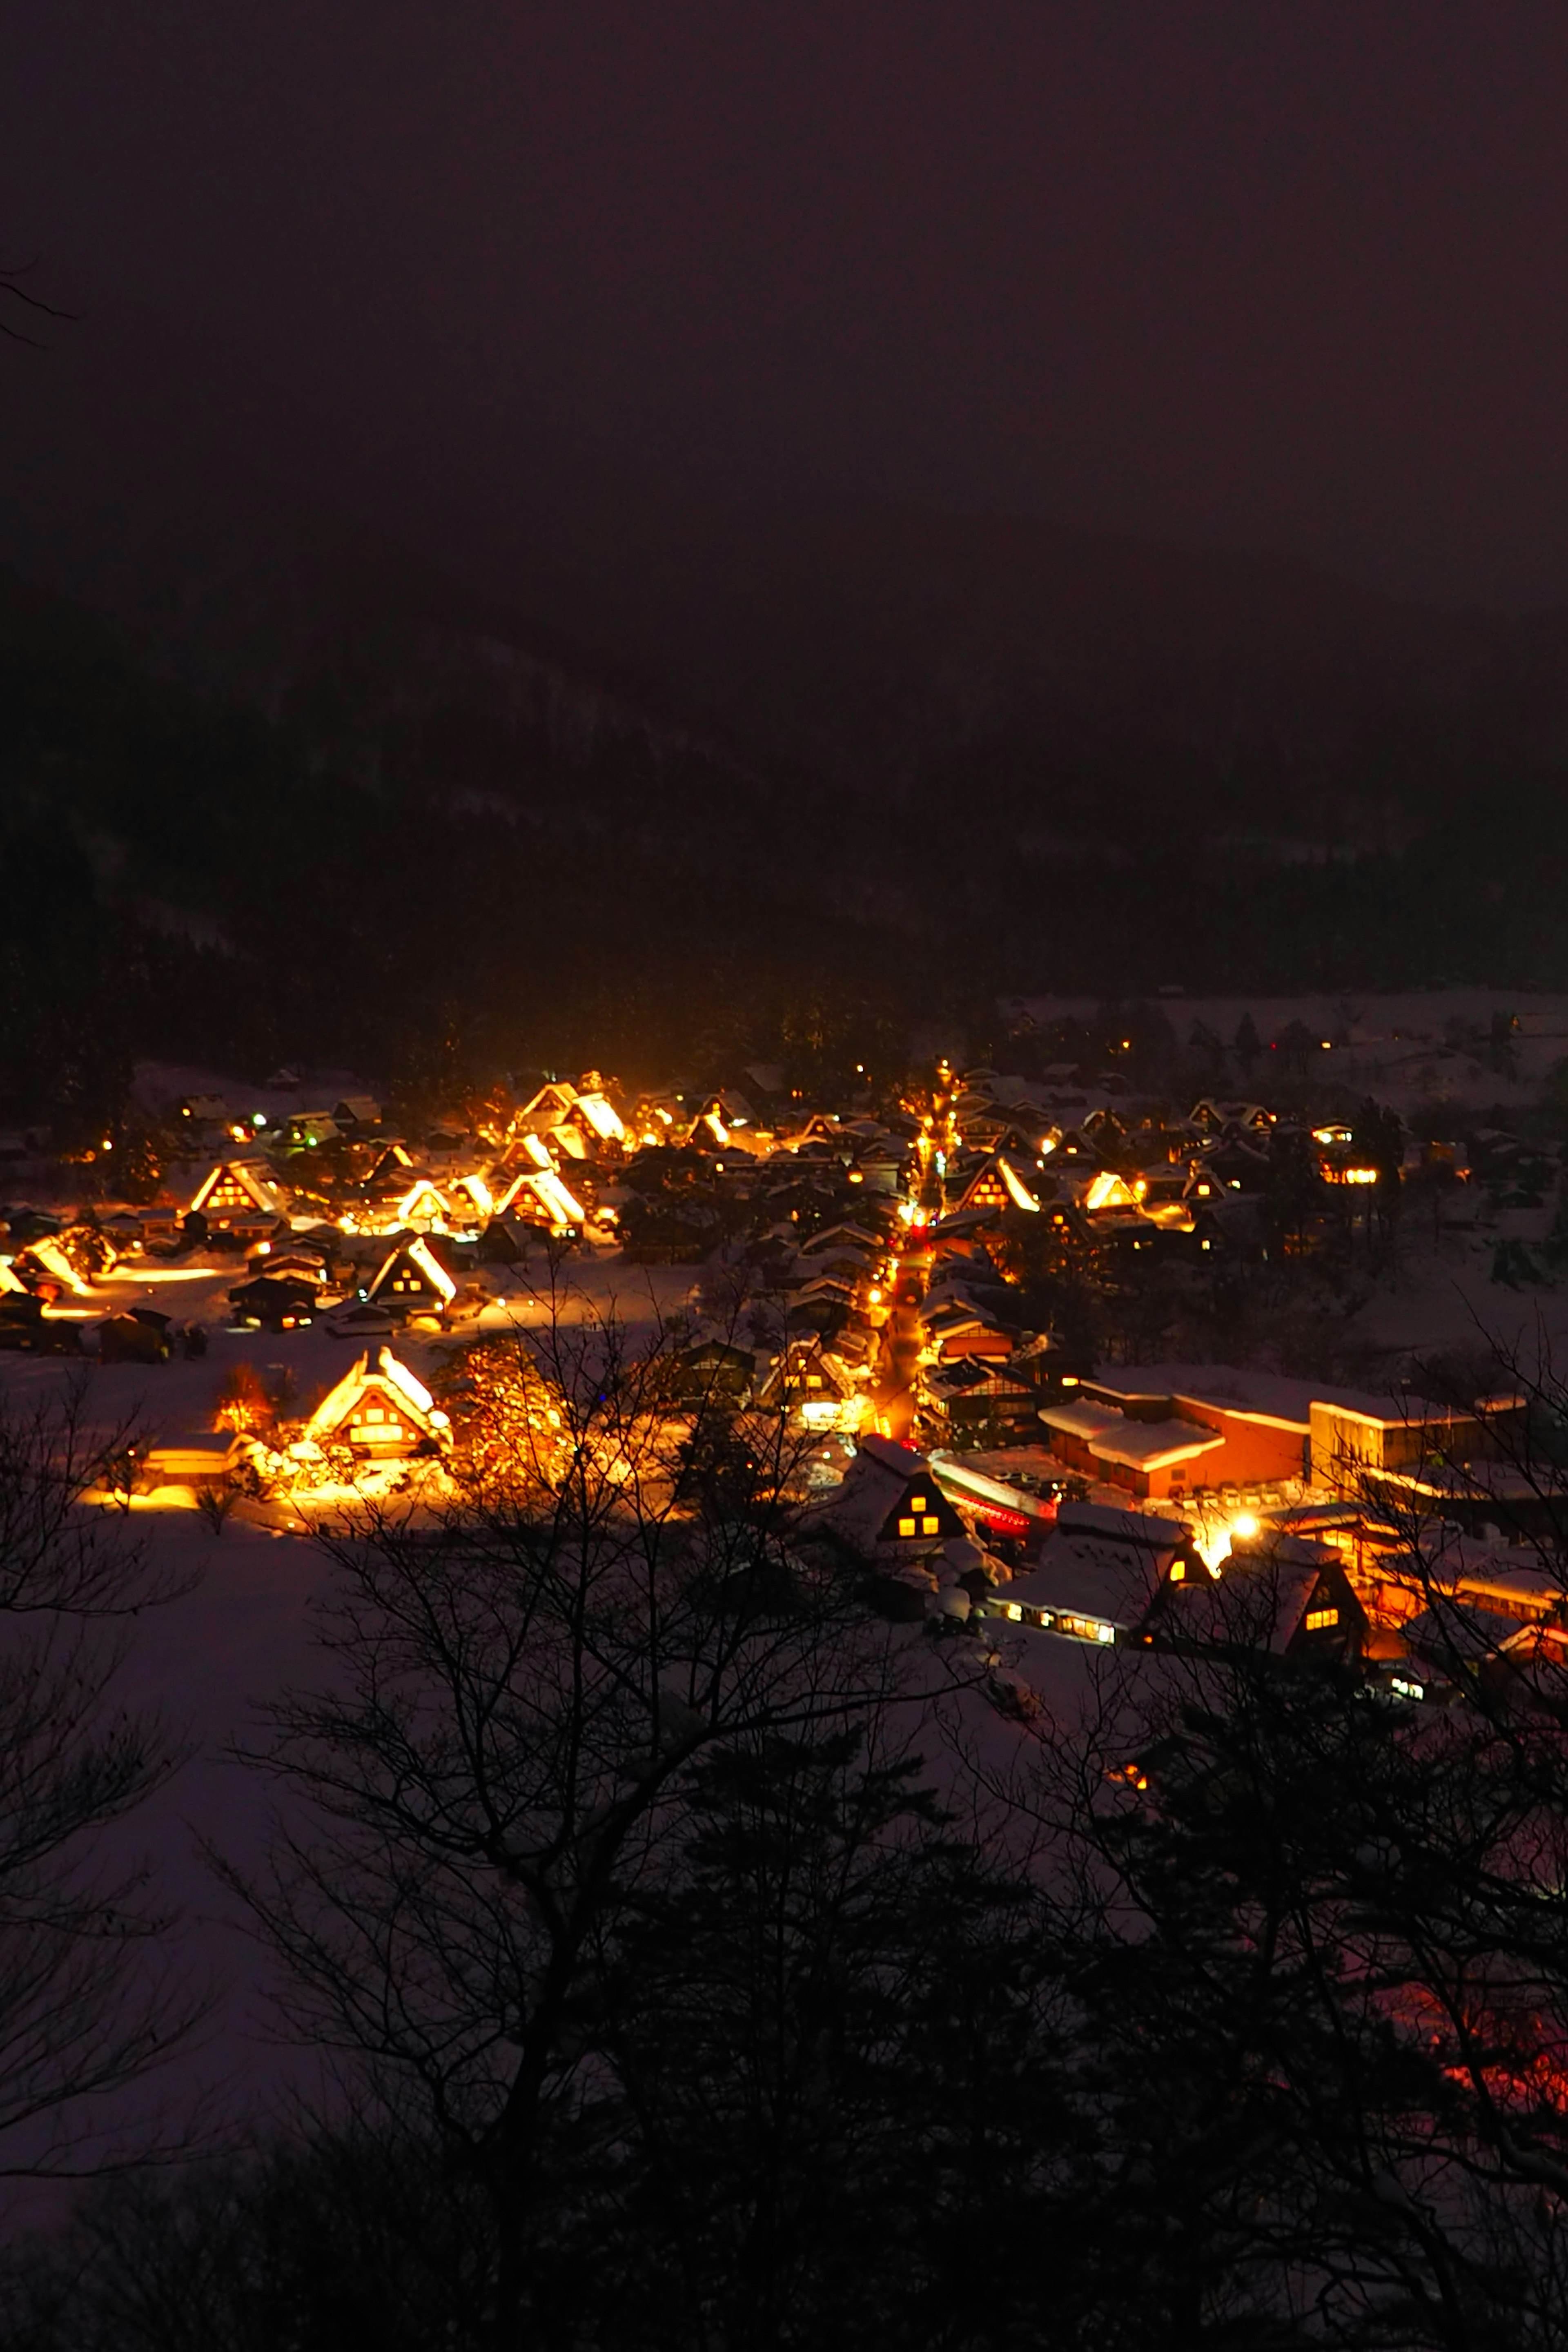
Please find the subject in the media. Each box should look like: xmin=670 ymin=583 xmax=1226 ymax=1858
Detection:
xmin=0 ymin=343 xmax=1568 ymax=1117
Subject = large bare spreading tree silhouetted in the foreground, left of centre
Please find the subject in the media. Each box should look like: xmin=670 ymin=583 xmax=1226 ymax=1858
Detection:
xmin=230 ymin=1287 xmax=926 ymax=2345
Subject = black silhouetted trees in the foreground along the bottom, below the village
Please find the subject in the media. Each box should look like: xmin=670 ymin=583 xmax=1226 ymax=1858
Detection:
xmin=7 ymin=1571 xmax=1568 ymax=2352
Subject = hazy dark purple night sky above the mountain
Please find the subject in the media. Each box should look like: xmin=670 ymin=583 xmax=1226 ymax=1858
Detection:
xmin=0 ymin=0 xmax=1568 ymax=595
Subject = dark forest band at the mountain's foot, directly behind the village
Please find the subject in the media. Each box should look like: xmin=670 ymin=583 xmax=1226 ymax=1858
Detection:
xmin=0 ymin=564 xmax=1568 ymax=1138
